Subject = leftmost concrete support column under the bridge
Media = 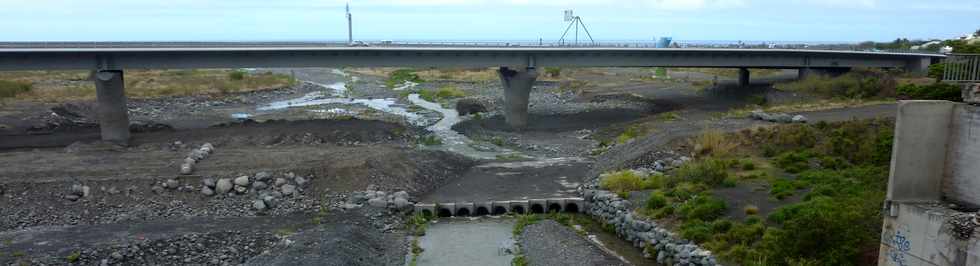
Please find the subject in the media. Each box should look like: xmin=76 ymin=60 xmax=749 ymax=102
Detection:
xmin=95 ymin=70 xmax=129 ymax=145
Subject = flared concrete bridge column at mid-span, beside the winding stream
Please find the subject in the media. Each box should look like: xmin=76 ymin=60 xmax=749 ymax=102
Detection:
xmin=497 ymin=67 xmax=538 ymax=130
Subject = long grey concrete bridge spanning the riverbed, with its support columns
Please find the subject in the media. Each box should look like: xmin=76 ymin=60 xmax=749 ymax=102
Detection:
xmin=0 ymin=42 xmax=945 ymax=144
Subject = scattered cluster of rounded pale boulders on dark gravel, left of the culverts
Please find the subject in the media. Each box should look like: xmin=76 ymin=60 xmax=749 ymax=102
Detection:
xmin=201 ymin=172 xmax=310 ymax=211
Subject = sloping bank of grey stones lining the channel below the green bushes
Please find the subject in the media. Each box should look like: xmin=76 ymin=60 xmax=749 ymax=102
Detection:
xmin=581 ymin=184 xmax=717 ymax=265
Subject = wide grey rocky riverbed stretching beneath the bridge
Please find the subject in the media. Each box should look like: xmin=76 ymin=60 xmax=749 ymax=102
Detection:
xmin=0 ymin=66 xmax=894 ymax=265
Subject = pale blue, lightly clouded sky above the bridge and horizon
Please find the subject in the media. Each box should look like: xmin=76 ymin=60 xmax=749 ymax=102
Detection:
xmin=0 ymin=0 xmax=980 ymax=42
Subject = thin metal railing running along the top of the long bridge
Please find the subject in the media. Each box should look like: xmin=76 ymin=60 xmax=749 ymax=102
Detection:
xmin=0 ymin=41 xmax=937 ymax=54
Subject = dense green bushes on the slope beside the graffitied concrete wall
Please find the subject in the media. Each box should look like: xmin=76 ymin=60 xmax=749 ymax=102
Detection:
xmin=660 ymin=120 xmax=894 ymax=265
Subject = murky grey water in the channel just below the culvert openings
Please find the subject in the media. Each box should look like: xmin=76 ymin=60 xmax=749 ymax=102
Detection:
xmin=405 ymin=217 xmax=514 ymax=266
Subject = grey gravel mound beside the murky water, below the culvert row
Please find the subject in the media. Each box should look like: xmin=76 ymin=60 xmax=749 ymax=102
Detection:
xmin=521 ymin=220 xmax=626 ymax=266
